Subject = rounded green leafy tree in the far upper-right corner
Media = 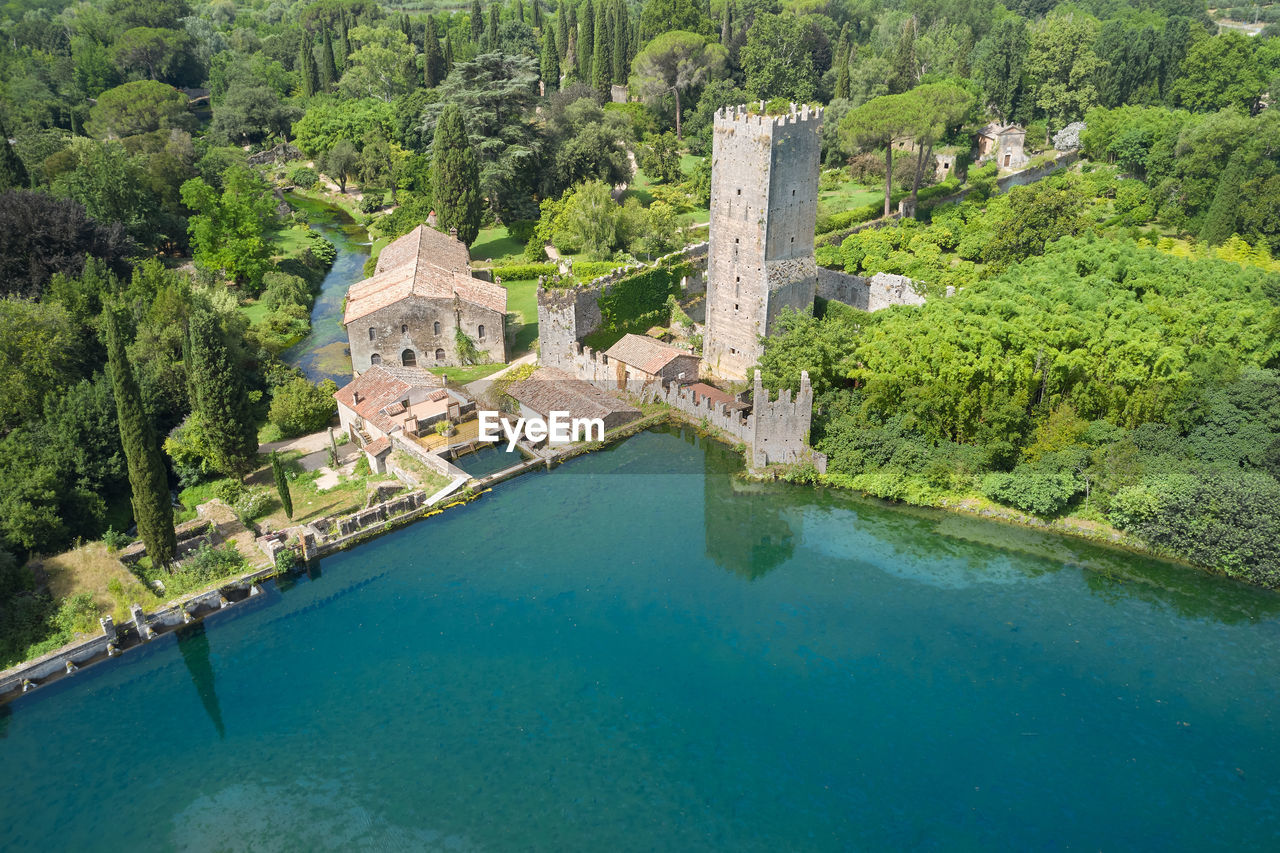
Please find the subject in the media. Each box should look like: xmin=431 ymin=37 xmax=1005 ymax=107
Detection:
xmin=1174 ymin=29 xmax=1268 ymax=111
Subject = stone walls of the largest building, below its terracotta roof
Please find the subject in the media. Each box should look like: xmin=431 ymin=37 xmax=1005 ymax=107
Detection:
xmin=347 ymin=296 xmax=507 ymax=375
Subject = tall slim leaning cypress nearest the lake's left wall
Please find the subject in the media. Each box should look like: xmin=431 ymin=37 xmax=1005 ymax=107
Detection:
xmin=102 ymin=306 xmax=178 ymax=567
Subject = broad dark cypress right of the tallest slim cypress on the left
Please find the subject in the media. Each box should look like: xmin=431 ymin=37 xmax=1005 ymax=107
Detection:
xmin=187 ymin=311 xmax=257 ymax=474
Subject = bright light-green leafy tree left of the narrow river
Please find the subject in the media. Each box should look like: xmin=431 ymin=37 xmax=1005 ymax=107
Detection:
xmin=182 ymin=165 xmax=275 ymax=293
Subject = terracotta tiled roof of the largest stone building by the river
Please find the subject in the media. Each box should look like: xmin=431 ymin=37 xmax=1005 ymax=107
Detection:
xmin=342 ymin=225 xmax=507 ymax=324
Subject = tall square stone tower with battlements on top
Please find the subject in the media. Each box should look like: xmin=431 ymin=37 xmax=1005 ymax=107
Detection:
xmin=703 ymin=104 xmax=822 ymax=379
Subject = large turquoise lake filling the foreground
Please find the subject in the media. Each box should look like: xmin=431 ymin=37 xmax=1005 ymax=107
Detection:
xmin=0 ymin=432 xmax=1280 ymax=850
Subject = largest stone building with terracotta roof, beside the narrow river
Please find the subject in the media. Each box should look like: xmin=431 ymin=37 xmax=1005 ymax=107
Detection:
xmin=343 ymin=225 xmax=507 ymax=375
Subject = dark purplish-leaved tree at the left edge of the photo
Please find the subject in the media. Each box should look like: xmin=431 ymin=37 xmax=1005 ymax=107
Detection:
xmin=0 ymin=190 xmax=133 ymax=297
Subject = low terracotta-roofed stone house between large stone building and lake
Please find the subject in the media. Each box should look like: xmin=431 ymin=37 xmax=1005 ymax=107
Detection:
xmin=333 ymin=364 xmax=475 ymax=474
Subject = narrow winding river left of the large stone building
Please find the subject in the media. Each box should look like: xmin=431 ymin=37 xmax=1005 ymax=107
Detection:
xmin=280 ymin=193 xmax=370 ymax=386
